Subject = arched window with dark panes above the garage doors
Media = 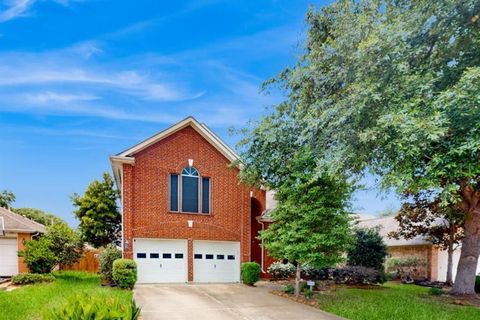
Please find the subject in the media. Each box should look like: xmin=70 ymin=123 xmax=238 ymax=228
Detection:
xmin=170 ymin=166 xmax=210 ymax=214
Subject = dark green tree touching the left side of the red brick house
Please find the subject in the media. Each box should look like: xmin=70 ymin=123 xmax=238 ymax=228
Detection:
xmin=72 ymin=172 xmax=121 ymax=247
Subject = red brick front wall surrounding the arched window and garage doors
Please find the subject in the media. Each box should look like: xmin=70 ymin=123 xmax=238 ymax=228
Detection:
xmin=119 ymin=127 xmax=265 ymax=280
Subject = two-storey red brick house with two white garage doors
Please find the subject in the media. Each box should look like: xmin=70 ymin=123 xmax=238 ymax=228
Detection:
xmin=110 ymin=117 xmax=271 ymax=283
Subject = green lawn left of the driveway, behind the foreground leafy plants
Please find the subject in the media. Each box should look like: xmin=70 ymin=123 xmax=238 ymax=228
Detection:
xmin=0 ymin=271 xmax=132 ymax=320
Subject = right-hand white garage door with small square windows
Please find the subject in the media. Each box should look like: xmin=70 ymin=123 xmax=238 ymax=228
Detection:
xmin=193 ymin=241 xmax=240 ymax=282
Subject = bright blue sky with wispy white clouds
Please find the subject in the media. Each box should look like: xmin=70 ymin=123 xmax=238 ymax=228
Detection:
xmin=0 ymin=0 xmax=398 ymax=225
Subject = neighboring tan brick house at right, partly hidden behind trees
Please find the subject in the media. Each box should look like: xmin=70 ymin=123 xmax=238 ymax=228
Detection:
xmin=358 ymin=215 xmax=480 ymax=281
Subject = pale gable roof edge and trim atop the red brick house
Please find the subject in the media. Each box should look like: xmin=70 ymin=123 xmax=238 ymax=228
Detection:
xmin=110 ymin=116 xmax=240 ymax=190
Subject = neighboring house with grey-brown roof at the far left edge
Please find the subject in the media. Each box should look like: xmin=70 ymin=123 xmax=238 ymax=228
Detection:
xmin=0 ymin=207 xmax=45 ymax=277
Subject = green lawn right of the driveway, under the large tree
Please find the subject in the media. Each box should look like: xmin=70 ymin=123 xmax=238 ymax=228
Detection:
xmin=318 ymin=282 xmax=480 ymax=320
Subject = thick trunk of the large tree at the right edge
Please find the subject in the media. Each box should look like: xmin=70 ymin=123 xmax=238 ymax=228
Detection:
xmin=451 ymin=206 xmax=480 ymax=295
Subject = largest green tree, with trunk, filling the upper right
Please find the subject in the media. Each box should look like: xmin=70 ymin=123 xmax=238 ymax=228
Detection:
xmin=253 ymin=0 xmax=480 ymax=294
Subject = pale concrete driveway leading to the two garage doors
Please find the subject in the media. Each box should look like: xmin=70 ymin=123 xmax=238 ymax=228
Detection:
xmin=134 ymin=284 xmax=341 ymax=320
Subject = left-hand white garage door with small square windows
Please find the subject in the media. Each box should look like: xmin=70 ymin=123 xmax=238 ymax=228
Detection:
xmin=133 ymin=239 xmax=188 ymax=283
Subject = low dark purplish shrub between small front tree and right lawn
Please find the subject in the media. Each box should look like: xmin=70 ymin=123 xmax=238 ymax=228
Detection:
xmin=329 ymin=266 xmax=382 ymax=284
